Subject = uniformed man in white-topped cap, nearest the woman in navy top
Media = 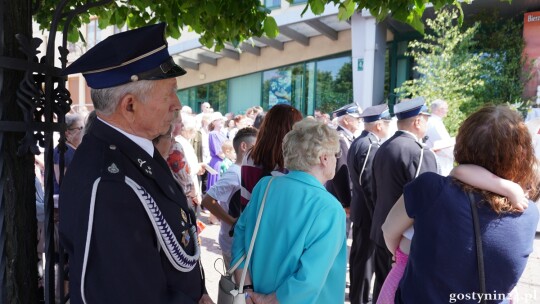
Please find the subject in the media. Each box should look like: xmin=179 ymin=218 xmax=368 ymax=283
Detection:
xmin=370 ymin=97 xmax=438 ymax=301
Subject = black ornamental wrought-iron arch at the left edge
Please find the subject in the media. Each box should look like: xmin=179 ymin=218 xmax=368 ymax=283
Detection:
xmin=0 ymin=0 xmax=112 ymax=304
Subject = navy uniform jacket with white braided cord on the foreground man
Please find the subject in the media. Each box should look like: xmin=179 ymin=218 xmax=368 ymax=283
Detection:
xmin=60 ymin=119 xmax=206 ymax=304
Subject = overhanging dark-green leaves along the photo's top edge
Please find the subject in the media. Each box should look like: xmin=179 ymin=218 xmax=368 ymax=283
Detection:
xmin=34 ymin=0 xmax=472 ymax=50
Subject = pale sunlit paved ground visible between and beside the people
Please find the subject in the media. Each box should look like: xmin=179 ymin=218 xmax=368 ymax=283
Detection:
xmin=201 ymin=214 xmax=540 ymax=304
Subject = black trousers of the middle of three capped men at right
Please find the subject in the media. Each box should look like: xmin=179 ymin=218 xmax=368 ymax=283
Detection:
xmin=349 ymin=224 xmax=375 ymax=304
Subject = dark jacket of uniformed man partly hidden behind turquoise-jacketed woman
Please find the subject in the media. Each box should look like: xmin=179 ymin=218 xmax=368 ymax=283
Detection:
xmin=325 ymin=126 xmax=354 ymax=208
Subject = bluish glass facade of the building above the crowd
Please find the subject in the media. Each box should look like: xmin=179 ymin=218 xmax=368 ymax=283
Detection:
xmin=177 ymin=53 xmax=353 ymax=115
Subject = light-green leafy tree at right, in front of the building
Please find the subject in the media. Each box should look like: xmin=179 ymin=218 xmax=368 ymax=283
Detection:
xmin=396 ymin=6 xmax=531 ymax=134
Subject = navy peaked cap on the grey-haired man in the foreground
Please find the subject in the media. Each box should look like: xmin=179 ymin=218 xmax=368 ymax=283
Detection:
xmin=62 ymin=23 xmax=186 ymax=89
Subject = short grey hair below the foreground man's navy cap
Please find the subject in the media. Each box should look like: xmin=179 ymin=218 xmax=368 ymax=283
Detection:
xmin=90 ymin=80 xmax=155 ymax=115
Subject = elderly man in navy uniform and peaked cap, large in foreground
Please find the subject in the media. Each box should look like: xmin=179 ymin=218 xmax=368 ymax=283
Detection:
xmin=60 ymin=23 xmax=212 ymax=304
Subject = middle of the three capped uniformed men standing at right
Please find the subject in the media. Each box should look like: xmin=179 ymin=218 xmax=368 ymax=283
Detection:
xmin=347 ymin=104 xmax=391 ymax=304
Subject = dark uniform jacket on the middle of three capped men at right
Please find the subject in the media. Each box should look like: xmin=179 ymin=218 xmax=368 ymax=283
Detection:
xmin=347 ymin=130 xmax=380 ymax=229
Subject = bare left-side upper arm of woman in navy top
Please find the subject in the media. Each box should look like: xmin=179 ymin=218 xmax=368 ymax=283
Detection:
xmin=381 ymin=195 xmax=413 ymax=255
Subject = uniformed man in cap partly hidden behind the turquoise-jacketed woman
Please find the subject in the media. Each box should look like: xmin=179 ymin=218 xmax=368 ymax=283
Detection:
xmin=325 ymin=103 xmax=360 ymax=236
